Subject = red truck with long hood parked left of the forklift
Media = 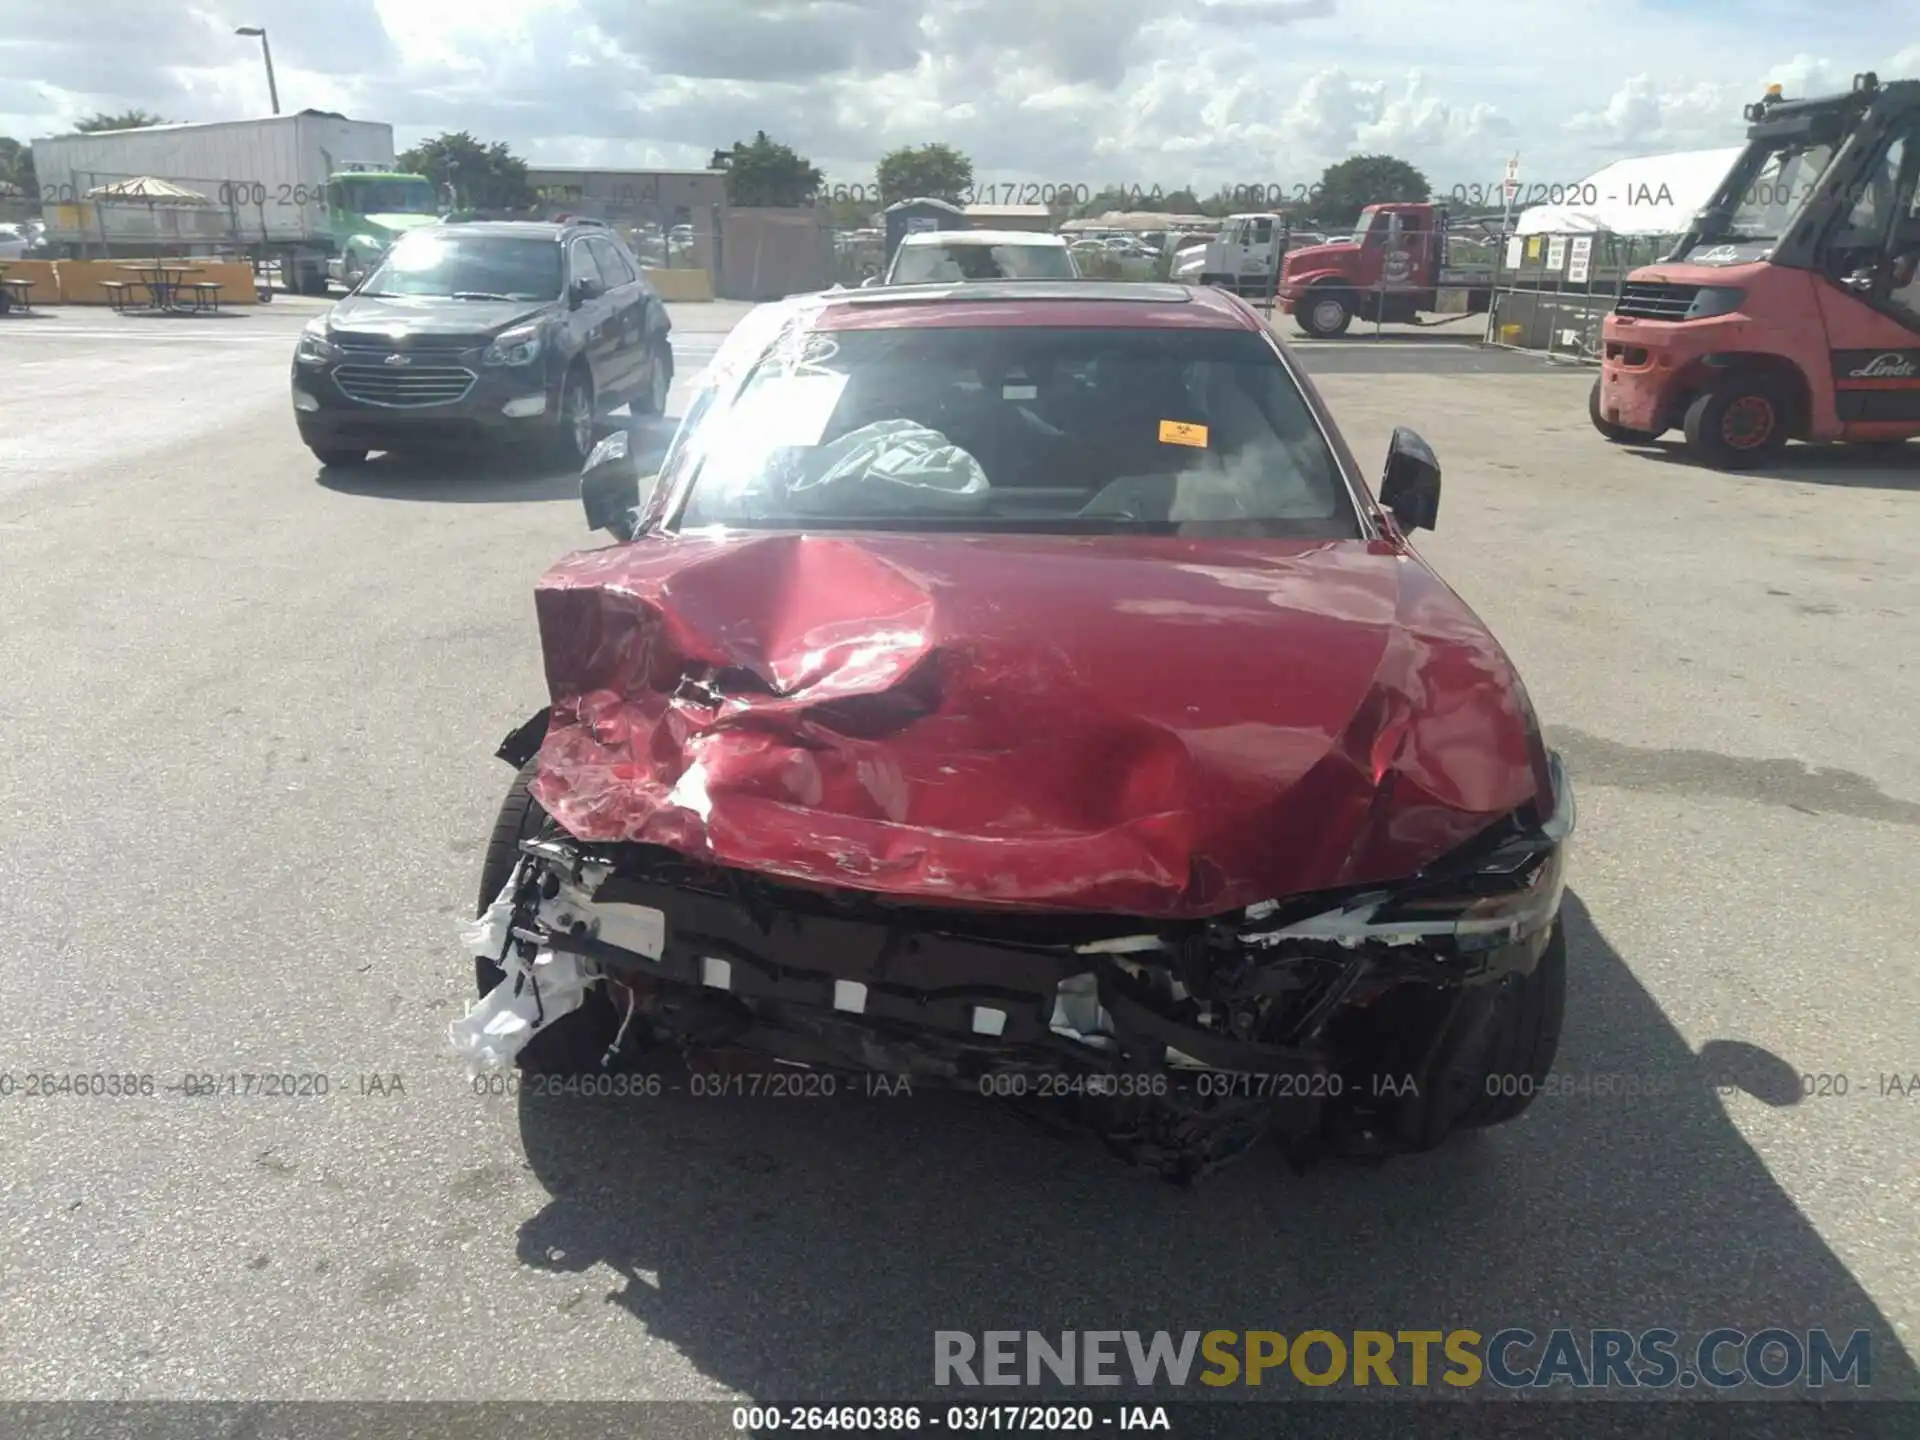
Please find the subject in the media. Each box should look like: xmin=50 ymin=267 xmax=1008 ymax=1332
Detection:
xmin=1275 ymin=204 xmax=1500 ymax=338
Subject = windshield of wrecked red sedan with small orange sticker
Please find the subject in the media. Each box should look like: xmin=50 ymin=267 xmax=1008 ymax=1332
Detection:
xmin=668 ymin=323 xmax=1359 ymax=538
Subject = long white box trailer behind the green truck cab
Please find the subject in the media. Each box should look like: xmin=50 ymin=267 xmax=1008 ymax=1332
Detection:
xmin=33 ymin=109 xmax=394 ymax=288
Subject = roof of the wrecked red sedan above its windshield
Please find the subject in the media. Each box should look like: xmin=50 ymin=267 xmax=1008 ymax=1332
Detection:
xmin=806 ymin=280 xmax=1263 ymax=330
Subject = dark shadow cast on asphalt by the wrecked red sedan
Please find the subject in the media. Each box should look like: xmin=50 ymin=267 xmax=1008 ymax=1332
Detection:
xmin=503 ymin=895 xmax=1920 ymax=1413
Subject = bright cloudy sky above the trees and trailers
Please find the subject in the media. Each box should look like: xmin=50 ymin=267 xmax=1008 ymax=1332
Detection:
xmin=0 ymin=0 xmax=1920 ymax=190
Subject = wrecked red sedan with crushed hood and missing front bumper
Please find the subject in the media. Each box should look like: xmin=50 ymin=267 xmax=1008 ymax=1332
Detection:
xmin=453 ymin=282 xmax=1572 ymax=1181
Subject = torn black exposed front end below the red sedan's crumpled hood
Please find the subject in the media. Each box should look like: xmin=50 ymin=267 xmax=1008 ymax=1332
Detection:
xmin=453 ymin=756 xmax=1574 ymax=1177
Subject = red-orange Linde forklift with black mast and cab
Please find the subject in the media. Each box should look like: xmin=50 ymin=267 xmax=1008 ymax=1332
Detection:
xmin=1588 ymin=75 xmax=1920 ymax=470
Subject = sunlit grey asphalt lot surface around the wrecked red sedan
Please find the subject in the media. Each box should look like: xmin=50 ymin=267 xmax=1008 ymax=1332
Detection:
xmin=0 ymin=301 xmax=1920 ymax=1402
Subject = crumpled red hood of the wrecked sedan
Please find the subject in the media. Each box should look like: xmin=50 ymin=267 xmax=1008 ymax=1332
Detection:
xmin=534 ymin=534 xmax=1546 ymax=918
